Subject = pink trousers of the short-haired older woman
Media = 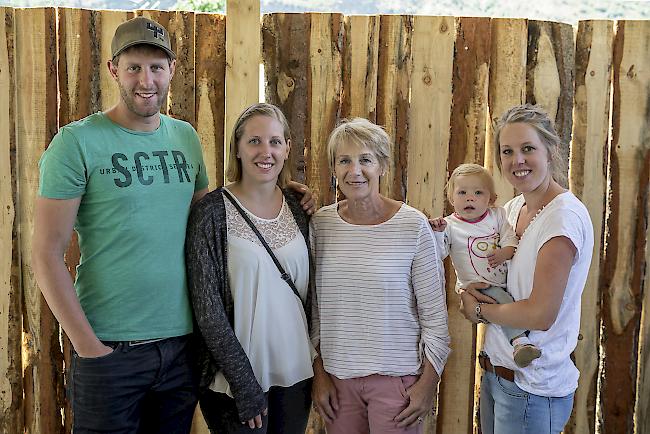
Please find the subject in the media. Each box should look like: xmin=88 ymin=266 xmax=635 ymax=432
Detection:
xmin=326 ymin=374 xmax=423 ymax=434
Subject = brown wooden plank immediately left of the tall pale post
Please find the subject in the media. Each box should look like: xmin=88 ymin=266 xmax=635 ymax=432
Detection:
xmin=195 ymin=14 xmax=229 ymax=190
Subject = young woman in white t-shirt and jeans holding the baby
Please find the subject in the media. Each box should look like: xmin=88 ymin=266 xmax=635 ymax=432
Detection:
xmin=461 ymin=105 xmax=594 ymax=434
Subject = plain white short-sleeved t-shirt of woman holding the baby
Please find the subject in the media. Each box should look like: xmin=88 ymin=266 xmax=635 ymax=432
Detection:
xmin=483 ymin=192 xmax=594 ymax=397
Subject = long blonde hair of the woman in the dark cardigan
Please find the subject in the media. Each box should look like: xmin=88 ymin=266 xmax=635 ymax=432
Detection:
xmin=226 ymin=102 xmax=291 ymax=187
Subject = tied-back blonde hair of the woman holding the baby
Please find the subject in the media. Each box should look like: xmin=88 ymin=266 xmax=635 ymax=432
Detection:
xmin=494 ymin=104 xmax=566 ymax=184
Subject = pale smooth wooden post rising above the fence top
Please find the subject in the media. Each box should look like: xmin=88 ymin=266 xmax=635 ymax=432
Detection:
xmin=224 ymin=0 xmax=261 ymax=176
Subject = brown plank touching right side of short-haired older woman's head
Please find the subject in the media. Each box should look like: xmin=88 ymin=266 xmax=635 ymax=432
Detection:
xmin=377 ymin=15 xmax=413 ymax=201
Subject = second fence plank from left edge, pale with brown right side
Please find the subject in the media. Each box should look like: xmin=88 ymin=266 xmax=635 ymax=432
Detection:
xmin=15 ymin=8 xmax=64 ymax=433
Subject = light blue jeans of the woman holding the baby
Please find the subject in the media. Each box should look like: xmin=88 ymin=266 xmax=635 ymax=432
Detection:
xmin=479 ymin=371 xmax=573 ymax=434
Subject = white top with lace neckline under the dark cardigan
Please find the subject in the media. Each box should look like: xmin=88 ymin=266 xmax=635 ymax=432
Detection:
xmin=210 ymin=187 xmax=316 ymax=397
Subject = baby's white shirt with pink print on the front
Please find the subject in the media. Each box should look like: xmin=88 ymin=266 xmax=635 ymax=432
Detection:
xmin=443 ymin=207 xmax=518 ymax=292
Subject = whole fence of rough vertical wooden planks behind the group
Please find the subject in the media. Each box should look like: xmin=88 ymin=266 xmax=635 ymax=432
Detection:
xmin=0 ymin=5 xmax=650 ymax=434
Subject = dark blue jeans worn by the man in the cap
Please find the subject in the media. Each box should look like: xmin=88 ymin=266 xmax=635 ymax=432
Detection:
xmin=68 ymin=336 xmax=198 ymax=434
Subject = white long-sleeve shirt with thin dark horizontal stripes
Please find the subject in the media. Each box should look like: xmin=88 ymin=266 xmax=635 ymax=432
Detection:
xmin=310 ymin=204 xmax=450 ymax=379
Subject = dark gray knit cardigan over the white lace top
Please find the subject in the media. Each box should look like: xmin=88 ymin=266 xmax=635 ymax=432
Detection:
xmin=185 ymin=188 xmax=313 ymax=421
